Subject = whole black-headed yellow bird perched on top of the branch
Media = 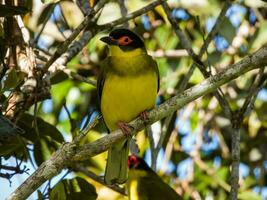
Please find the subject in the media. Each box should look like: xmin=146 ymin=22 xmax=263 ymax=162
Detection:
xmin=97 ymin=28 xmax=159 ymax=184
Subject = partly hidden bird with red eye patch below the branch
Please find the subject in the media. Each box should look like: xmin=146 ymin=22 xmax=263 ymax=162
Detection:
xmin=126 ymin=155 xmax=182 ymax=200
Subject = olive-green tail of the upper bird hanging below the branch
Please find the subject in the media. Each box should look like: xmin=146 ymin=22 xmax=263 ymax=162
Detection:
xmin=105 ymin=140 xmax=130 ymax=184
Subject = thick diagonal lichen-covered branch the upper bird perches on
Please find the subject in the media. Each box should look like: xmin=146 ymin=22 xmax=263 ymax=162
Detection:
xmin=8 ymin=46 xmax=267 ymax=200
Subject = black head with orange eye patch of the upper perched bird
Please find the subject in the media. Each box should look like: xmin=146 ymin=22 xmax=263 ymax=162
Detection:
xmin=100 ymin=28 xmax=144 ymax=51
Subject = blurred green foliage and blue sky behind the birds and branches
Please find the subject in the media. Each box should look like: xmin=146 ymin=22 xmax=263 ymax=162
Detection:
xmin=0 ymin=0 xmax=267 ymax=200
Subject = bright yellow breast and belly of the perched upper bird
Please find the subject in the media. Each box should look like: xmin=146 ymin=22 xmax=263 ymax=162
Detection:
xmin=101 ymin=71 xmax=158 ymax=131
